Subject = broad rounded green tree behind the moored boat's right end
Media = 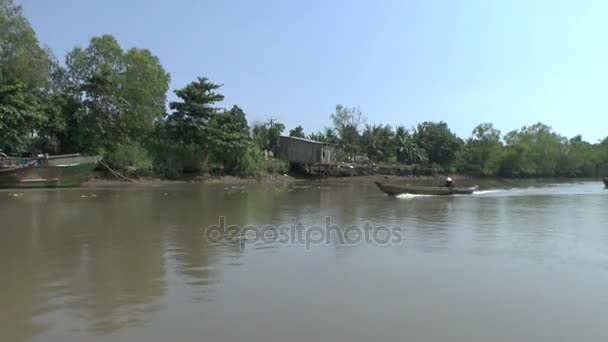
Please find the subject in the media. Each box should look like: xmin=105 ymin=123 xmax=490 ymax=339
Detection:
xmin=64 ymin=35 xmax=169 ymax=151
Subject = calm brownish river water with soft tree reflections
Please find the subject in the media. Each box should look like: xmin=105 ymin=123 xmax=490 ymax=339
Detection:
xmin=0 ymin=181 xmax=608 ymax=342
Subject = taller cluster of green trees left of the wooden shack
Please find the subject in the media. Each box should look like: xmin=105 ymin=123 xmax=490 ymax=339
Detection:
xmin=0 ymin=0 xmax=281 ymax=176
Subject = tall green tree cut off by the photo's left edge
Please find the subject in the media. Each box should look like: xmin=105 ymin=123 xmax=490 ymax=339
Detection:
xmin=0 ymin=0 xmax=63 ymax=153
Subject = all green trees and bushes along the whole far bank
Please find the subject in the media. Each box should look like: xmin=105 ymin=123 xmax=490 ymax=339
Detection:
xmin=0 ymin=0 xmax=608 ymax=178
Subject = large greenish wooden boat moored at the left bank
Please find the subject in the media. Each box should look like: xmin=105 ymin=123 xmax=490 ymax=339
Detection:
xmin=0 ymin=153 xmax=101 ymax=188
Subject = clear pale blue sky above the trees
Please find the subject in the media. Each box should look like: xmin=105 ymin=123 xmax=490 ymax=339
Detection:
xmin=16 ymin=0 xmax=608 ymax=142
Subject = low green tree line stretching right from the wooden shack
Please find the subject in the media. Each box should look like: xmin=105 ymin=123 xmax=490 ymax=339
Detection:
xmin=290 ymin=105 xmax=608 ymax=177
